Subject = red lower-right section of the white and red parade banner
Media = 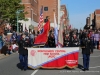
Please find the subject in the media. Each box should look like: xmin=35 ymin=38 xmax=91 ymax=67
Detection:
xmin=42 ymin=52 xmax=78 ymax=68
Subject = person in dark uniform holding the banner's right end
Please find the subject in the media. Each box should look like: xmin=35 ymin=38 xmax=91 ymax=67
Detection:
xmin=82 ymin=36 xmax=93 ymax=71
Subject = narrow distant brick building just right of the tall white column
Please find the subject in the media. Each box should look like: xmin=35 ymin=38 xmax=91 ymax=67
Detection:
xmin=60 ymin=5 xmax=69 ymax=26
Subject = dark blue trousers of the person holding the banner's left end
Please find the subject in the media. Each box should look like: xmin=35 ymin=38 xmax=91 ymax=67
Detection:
xmin=19 ymin=54 xmax=28 ymax=69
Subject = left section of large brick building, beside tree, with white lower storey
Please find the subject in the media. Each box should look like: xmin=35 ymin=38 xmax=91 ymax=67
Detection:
xmin=19 ymin=0 xmax=38 ymax=30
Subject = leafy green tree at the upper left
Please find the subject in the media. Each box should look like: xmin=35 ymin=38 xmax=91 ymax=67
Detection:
xmin=0 ymin=0 xmax=27 ymax=25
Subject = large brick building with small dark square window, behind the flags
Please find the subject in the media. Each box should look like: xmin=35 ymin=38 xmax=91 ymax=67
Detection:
xmin=19 ymin=0 xmax=60 ymax=30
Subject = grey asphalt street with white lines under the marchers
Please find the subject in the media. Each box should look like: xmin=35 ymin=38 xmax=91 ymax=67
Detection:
xmin=0 ymin=50 xmax=100 ymax=75
